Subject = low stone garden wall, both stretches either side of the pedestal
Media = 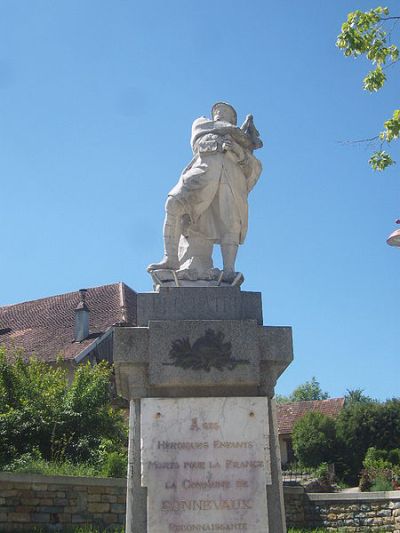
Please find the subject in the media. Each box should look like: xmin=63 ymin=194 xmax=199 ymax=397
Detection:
xmin=0 ymin=473 xmax=400 ymax=533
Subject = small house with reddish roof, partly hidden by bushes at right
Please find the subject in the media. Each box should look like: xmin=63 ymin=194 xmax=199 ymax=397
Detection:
xmin=277 ymin=398 xmax=344 ymax=465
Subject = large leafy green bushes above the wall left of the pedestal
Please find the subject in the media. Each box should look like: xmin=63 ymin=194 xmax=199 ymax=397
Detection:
xmin=0 ymin=349 xmax=126 ymax=470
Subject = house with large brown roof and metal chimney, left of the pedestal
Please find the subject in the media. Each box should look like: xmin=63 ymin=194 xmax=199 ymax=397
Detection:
xmin=0 ymin=283 xmax=136 ymax=373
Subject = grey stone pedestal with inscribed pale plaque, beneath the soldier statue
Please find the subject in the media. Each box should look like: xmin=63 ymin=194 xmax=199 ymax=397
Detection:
xmin=114 ymin=287 xmax=293 ymax=533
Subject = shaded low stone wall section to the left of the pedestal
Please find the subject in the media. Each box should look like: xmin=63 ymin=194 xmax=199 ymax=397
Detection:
xmin=0 ymin=473 xmax=126 ymax=533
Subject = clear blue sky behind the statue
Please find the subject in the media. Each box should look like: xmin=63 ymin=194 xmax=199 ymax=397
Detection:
xmin=0 ymin=0 xmax=400 ymax=399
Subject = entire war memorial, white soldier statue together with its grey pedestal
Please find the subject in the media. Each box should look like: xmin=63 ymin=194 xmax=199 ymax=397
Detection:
xmin=114 ymin=102 xmax=293 ymax=533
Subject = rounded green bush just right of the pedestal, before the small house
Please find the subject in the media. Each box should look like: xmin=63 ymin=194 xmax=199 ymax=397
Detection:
xmin=292 ymin=412 xmax=336 ymax=467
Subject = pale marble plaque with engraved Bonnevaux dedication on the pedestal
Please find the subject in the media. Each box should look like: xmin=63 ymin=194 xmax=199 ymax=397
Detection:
xmin=141 ymin=398 xmax=271 ymax=533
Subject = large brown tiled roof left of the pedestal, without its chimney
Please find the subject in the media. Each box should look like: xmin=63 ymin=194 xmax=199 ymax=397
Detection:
xmin=0 ymin=283 xmax=136 ymax=362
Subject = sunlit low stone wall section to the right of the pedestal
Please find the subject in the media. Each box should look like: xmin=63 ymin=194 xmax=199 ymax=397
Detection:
xmin=285 ymin=487 xmax=400 ymax=533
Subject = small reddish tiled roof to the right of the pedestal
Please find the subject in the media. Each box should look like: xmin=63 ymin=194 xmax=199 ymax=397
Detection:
xmin=278 ymin=398 xmax=344 ymax=435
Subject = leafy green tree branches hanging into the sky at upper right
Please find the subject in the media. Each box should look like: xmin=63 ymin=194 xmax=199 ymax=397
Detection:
xmin=336 ymin=6 xmax=400 ymax=171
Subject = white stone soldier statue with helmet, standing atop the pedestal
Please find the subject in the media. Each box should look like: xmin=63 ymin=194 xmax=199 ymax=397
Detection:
xmin=147 ymin=102 xmax=262 ymax=285
